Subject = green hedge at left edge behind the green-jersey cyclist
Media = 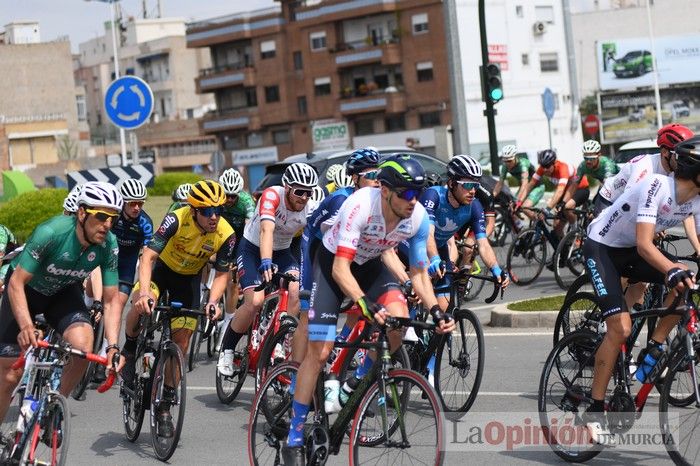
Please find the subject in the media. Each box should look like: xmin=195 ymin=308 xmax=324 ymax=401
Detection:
xmin=0 ymin=188 xmax=68 ymax=243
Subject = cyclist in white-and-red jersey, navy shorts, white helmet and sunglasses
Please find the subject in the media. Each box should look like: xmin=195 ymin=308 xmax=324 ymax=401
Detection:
xmin=217 ymin=163 xmax=318 ymax=376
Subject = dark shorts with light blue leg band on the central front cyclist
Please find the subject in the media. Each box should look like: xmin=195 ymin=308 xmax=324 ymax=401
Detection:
xmin=309 ymin=245 xmax=406 ymax=341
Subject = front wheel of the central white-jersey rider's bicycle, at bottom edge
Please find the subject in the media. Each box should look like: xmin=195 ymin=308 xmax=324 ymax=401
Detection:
xmin=350 ymin=369 xmax=445 ymax=465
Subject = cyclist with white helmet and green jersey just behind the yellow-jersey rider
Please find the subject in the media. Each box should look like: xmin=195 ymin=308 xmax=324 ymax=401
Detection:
xmin=219 ymin=168 xmax=255 ymax=324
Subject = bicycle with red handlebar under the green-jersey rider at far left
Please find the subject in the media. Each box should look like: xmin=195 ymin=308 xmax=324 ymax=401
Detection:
xmin=0 ymin=338 xmax=118 ymax=466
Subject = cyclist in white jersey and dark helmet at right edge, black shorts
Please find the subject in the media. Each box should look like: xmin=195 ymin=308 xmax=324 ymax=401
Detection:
xmin=583 ymin=137 xmax=700 ymax=443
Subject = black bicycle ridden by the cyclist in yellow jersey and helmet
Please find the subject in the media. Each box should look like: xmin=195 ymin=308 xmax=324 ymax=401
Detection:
xmin=120 ymin=293 xmax=213 ymax=461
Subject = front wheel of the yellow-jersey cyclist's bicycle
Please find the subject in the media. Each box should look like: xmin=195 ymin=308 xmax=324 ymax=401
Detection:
xmin=151 ymin=344 xmax=187 ymax=461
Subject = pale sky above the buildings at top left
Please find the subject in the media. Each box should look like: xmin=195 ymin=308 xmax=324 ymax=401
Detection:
xmin=0 ymin=0 xmax=276 ymax=52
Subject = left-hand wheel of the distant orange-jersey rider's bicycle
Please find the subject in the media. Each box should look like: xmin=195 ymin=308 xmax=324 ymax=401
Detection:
xmin=507 ymin=228 xmax=547 ymax=285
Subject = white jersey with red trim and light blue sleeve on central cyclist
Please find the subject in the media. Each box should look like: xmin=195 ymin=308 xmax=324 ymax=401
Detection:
xmin=323 ymin=187 xmax=430 ymax=268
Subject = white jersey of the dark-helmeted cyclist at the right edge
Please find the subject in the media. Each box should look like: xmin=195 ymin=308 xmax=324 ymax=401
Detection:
xmin=588 ymin=174 xmax=700 ymax=248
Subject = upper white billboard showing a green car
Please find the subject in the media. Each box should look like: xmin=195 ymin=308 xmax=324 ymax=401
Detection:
xmin=596 ymin=34 xmax=700 ymax=91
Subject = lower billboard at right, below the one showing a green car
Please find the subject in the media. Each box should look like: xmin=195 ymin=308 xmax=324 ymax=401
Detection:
xmin=598 ymin=86 xmax=700 ymax=143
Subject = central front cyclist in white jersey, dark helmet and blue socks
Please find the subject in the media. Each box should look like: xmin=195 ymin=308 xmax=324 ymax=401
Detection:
xmin=282 ymin=154 xmax=454 ymax=465
